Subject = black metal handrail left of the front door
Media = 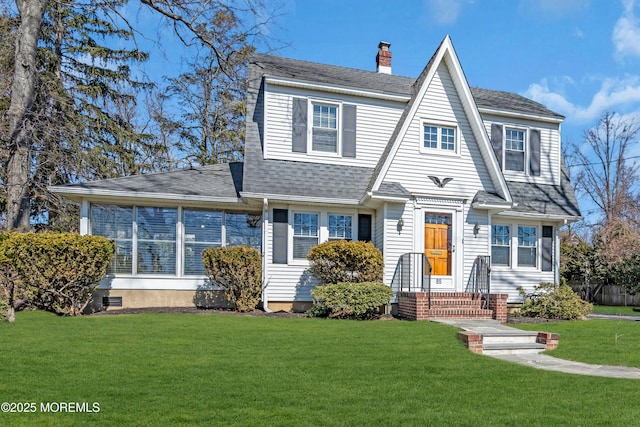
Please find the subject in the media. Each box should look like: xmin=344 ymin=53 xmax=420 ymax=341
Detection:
xmin=391 ymin=252 xmax=431 ymax=308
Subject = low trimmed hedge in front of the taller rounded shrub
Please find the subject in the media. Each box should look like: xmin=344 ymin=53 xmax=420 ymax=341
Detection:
xmin=307 ymin=282 xmax=393 ymax=319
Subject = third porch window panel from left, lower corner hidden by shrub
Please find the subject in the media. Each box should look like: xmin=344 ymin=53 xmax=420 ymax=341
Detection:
xmin=183 ymin=209 xmax=222 ymax=276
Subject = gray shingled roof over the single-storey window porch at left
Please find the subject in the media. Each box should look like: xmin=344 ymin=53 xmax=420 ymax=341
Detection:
xmin=52 ymin=162 xmax=243 ymax=199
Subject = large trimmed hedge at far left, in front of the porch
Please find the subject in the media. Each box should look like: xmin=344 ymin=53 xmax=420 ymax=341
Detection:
xmin=0 ymin=233 xmax=115 ymax=316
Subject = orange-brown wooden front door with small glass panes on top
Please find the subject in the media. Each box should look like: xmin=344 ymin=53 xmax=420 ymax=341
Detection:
xmin=424 ymin=212 xmax=451 ymax=276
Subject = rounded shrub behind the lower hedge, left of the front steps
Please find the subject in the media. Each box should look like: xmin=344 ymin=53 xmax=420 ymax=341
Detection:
xmin=307 ymin=240 xmax=384 ymax=285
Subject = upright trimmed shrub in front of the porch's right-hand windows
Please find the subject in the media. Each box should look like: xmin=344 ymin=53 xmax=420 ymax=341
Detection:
xmin=202 ymin=246 xmax=262 ymax=311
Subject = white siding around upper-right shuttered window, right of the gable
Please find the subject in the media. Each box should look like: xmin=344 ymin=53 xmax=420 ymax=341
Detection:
xmin=482 ymin=115 xmax=561 ymax=185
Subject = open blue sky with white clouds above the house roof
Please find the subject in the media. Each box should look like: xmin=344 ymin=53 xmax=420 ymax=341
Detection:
xmin=272 ymin=0 xmax=640 ymax=150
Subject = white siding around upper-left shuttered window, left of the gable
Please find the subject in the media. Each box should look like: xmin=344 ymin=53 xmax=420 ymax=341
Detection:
xmin=265 ymin=85 xmax=405 ymax=167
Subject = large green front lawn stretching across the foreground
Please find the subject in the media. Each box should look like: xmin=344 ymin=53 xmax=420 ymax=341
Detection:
xmin=0 ymin=312 xmax=640 ymax=426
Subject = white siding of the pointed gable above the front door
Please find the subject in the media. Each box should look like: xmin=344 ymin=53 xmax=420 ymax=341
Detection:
xmin=384 ymin=64 xmax=494 ymax=199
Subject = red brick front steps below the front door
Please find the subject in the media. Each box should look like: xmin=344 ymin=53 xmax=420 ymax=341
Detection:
xmin=398 ymin=292 xmax=507 ymax=323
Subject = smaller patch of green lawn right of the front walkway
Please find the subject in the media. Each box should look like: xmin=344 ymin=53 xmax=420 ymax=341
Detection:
xmin=513 ymin=319 xmax=640 ymax=368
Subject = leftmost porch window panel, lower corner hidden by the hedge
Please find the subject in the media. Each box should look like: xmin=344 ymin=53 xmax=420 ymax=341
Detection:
xmin=90 ymin=205 xmax=133 ymax=274
